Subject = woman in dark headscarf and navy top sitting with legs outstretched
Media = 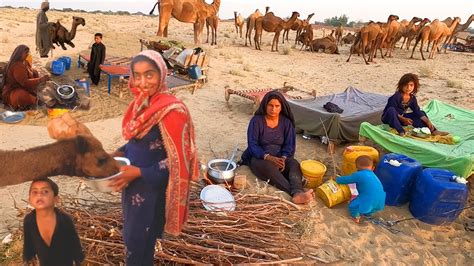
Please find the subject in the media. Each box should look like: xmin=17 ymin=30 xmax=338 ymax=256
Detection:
xmin=242 ymin=91 xmax=313 ymax=204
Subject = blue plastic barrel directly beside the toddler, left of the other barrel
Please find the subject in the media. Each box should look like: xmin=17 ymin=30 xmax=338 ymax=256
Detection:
xmin=375 ymin=153 xmax=423 ymax=206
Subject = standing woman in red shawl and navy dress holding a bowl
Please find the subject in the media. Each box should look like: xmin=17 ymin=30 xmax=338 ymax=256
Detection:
xmin=111 ymin=50 xmax=198 ymax=265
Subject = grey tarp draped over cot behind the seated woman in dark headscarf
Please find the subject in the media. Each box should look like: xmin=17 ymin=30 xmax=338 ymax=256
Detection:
xmin=288 ymin=87 xmax=388 ymax=141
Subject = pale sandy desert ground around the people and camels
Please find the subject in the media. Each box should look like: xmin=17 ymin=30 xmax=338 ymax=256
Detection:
xmin=0 ymin=9 xmax=474 ymax=265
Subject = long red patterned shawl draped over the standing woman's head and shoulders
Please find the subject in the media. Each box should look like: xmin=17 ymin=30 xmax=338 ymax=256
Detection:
xmin=122 ymin=50 xmax=199 ymax=235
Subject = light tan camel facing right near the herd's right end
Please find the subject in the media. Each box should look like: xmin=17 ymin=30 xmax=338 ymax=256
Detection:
xmin=410 ymin=17 xmax=461 ymax=60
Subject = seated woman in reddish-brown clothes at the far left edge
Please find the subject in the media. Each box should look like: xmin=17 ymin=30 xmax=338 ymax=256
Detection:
xmin=0 ymin=44 xmax=50 ymax=110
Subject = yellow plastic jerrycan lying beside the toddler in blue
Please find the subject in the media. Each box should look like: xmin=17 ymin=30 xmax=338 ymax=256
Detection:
xmin=316 ymin=179 xmax=351 ymax=208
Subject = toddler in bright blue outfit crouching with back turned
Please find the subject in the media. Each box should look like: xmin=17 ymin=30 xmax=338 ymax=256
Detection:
xmin=336 ymin=155 xmax=385 ymax=223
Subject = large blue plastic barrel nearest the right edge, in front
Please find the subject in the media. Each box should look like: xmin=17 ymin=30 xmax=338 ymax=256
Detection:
xmin=410 ymin=168 xmax=468 ymax=225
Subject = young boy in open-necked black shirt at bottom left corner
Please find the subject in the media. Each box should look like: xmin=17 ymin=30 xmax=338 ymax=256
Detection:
xmin=23 ymin=178 xmax=84 ymax=266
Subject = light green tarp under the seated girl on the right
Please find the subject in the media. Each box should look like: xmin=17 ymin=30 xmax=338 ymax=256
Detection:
xmin=359 ymin=100 xmax=474 ymax=177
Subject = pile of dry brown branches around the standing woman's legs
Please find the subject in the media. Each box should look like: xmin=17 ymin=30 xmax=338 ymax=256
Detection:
xmin=45 ymin=186 xmax=321 ymax=265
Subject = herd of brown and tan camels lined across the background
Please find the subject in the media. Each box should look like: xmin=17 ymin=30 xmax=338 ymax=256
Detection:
xmin=151 ymin=0 xmax=474 ymax=64
